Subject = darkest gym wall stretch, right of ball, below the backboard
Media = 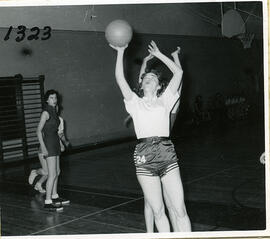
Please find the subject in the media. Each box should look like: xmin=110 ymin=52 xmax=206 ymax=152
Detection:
xmin=128 ymin=34 xmax=264 ymax=123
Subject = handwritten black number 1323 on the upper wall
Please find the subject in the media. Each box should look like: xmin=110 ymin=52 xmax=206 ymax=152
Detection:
xmin=4 ymin=25 xmax=52 ymax=42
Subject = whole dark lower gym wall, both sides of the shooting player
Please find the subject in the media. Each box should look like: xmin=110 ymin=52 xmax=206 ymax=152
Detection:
xmin=0 ymin=29 xmax=262 ymax=145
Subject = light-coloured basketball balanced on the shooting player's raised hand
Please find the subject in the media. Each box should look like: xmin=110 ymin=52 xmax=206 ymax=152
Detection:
xmin=105 ymin=20 xmax=132 ymax=47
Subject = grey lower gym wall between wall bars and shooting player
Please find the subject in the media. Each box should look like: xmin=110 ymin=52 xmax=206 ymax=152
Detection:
xmin=0 ymin=31 xmax=133 ymax=145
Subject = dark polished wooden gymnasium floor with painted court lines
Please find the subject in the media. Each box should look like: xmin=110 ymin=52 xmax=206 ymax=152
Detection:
xmin=0 ymin=117 xmax=265 ymax=236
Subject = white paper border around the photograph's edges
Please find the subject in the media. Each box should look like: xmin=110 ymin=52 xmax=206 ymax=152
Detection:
xmin=0 ymin=0 xmax=270 ymax=239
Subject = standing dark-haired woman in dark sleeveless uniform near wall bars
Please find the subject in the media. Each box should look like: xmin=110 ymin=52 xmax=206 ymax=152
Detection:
xmin=37 ymin=90 xmax=70 ymax=211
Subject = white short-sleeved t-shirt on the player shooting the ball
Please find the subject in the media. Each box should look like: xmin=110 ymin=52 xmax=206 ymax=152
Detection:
xmin=124 ymin=87 xmax=179 ymax=139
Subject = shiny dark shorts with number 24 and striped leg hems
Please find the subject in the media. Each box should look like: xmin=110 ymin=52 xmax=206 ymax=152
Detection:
xmin=134 ymin=137 xmax=178 ymax=177
